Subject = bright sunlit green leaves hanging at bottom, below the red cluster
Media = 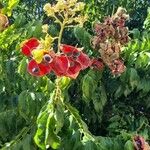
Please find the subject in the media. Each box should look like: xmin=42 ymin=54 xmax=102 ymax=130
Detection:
xmin=34 ymin=103 xmax=64 ymax=150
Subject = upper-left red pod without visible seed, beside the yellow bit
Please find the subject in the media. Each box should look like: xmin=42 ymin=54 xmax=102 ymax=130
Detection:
xmin=22 ymin=38 xmax=40 ymax=57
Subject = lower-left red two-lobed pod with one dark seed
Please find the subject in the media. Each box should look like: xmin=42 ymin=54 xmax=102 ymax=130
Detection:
xmin=27 ymin=59 xmax=52 ymax=77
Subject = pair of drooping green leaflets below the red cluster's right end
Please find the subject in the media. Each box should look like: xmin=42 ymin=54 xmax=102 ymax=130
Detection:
xmin=82 ymin=70 xmax=107 ymax=116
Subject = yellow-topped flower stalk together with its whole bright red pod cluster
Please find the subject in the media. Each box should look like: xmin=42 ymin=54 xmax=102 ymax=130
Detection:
xmin=21 ymin=0 xmax=91 ymax=79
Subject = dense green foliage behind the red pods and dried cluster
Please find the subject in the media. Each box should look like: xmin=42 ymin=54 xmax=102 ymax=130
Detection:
xmin=0 ymin=0 xmax=150 ymax=150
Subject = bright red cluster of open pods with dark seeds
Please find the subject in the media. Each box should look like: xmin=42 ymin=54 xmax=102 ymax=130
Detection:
xmin=22 ymin=38 xmax=91 ymax=79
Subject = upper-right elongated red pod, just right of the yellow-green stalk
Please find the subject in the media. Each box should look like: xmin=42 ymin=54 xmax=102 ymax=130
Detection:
xmin=60 ymin=44 xmax=90 ymax=70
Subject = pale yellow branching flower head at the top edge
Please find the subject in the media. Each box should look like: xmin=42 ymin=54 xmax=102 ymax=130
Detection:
xmin=44 ymin=0 xmax=87 ymax=26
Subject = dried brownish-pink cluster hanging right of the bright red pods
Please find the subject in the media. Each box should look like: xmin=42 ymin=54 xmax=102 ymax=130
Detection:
xmin=92 ymin=7 xmax=129 ymax=74
